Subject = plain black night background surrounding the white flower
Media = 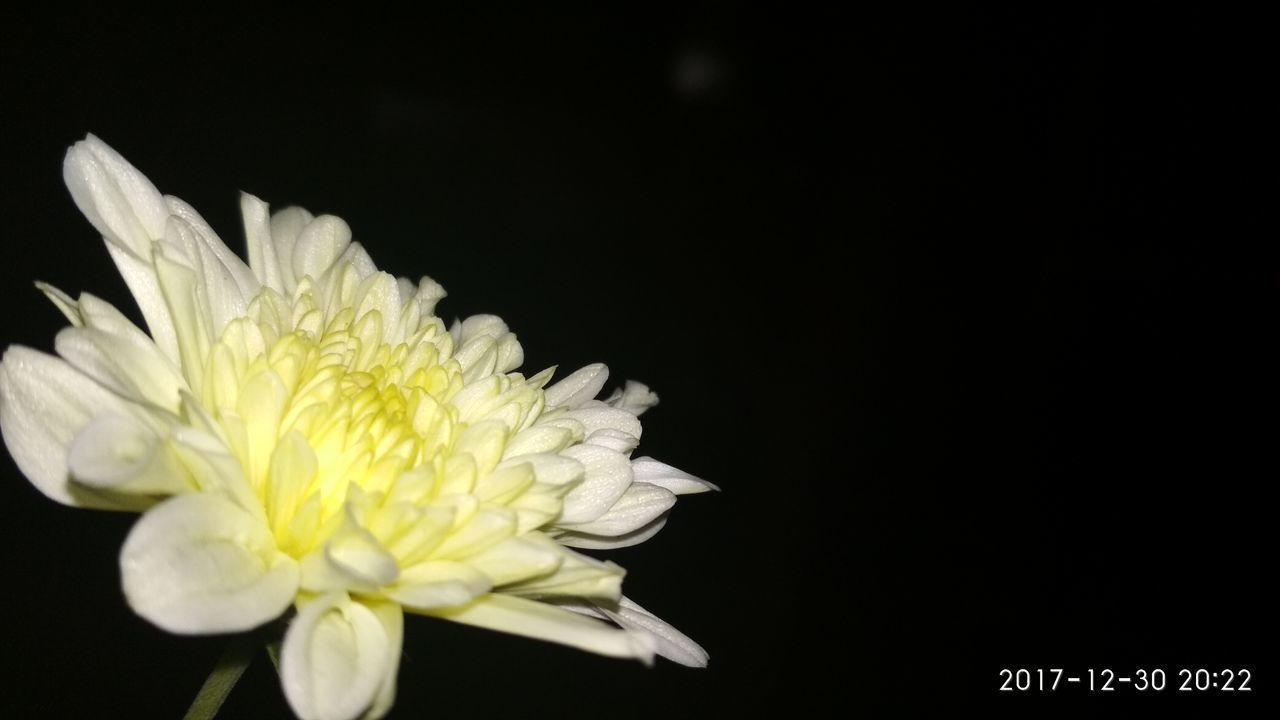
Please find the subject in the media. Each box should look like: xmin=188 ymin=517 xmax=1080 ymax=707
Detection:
xmin=0 ymin=3 xmax=1277 ymax=717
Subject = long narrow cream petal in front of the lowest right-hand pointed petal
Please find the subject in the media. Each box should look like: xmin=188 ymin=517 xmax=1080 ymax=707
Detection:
xmin=428 ymin=594 xmax=657 ymax=664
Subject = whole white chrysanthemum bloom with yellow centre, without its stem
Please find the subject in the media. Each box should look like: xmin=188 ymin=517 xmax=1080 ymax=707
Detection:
xmin=0 ymin=136 xmax=714 ymax=719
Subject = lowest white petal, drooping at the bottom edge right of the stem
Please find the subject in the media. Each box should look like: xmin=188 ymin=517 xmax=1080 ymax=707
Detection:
xmin=280 ymin=593 xmax=398 ymax=720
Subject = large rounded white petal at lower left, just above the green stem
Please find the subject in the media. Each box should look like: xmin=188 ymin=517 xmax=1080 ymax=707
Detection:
xmin=120 ymin=493 xmax=298 ymax=634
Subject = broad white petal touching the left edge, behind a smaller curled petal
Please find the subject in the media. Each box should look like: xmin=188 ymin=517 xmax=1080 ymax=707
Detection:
xmin=0 ymin=346 xmax=150 ymax=510
